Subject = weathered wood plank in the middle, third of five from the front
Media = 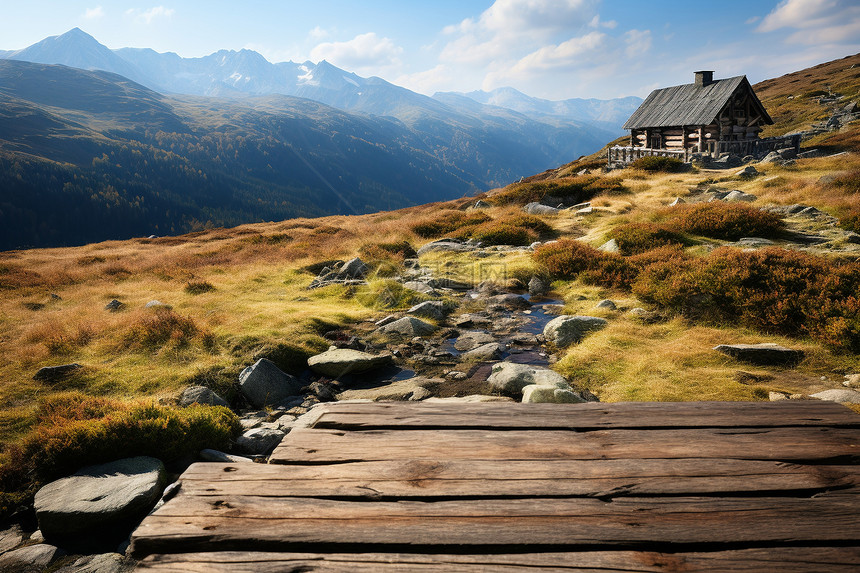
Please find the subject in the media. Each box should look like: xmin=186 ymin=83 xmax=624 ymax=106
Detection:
xmin=179 ymin=459 xmax=860 ymax=499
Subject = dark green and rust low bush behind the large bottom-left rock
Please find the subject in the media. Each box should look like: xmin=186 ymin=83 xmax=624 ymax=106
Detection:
xmin=0 ymin=393 xmax=242 ymax=519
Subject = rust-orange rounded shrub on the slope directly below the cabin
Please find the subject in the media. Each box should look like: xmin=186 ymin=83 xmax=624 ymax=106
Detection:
xmin=663 ymin=201 xmax=785 ymax=241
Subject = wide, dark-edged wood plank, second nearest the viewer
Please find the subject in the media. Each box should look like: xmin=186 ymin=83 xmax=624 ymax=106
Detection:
xmin=132 ymin=496 xmax=860 ymax=554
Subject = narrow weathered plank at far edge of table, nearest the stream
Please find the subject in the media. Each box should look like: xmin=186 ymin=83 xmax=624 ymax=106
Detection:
xmin=313 ymin=400 xmax=860 ymax=430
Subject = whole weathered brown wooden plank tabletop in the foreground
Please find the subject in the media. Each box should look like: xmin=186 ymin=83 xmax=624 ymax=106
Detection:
xmin=132 ymin=401 xmax=860 ymax=572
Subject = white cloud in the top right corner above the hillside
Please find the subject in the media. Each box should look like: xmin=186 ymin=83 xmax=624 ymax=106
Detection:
xmin=756 ymin=0 xmax=860 ymax=45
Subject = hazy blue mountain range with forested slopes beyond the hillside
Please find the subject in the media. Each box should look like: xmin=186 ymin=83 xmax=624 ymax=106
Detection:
xmin=0 ymin=28 xmax=641 ymax=248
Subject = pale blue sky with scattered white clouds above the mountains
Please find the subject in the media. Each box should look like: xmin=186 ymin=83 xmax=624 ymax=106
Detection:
xmin=0 ymin=0 xmax=860 ymax=100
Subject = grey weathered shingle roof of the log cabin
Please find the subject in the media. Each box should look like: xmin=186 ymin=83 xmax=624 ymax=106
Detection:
xmin=624 ymin=76 xmax=773 ymax=129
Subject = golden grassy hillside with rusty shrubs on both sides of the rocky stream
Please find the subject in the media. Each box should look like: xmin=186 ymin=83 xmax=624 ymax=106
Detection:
xmin=5 ymin=53 xmax=860 ymax=520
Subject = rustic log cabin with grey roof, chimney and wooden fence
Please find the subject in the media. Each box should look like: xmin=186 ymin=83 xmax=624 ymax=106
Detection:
xmin=609 ymin=71 xmax=800 ymax=165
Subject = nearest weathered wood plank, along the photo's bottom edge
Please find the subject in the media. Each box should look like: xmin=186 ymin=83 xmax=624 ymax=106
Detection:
xmin=138 ymin=547 xmax=860 ymax=573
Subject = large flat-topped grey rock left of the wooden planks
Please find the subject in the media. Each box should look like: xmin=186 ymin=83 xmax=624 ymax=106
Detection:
xmin=34 ymin=456 xmax=166 ymax=547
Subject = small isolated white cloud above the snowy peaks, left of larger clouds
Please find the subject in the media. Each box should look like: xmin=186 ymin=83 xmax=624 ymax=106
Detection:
xmin=311 ymin=32 xmax=403 ymax=73
